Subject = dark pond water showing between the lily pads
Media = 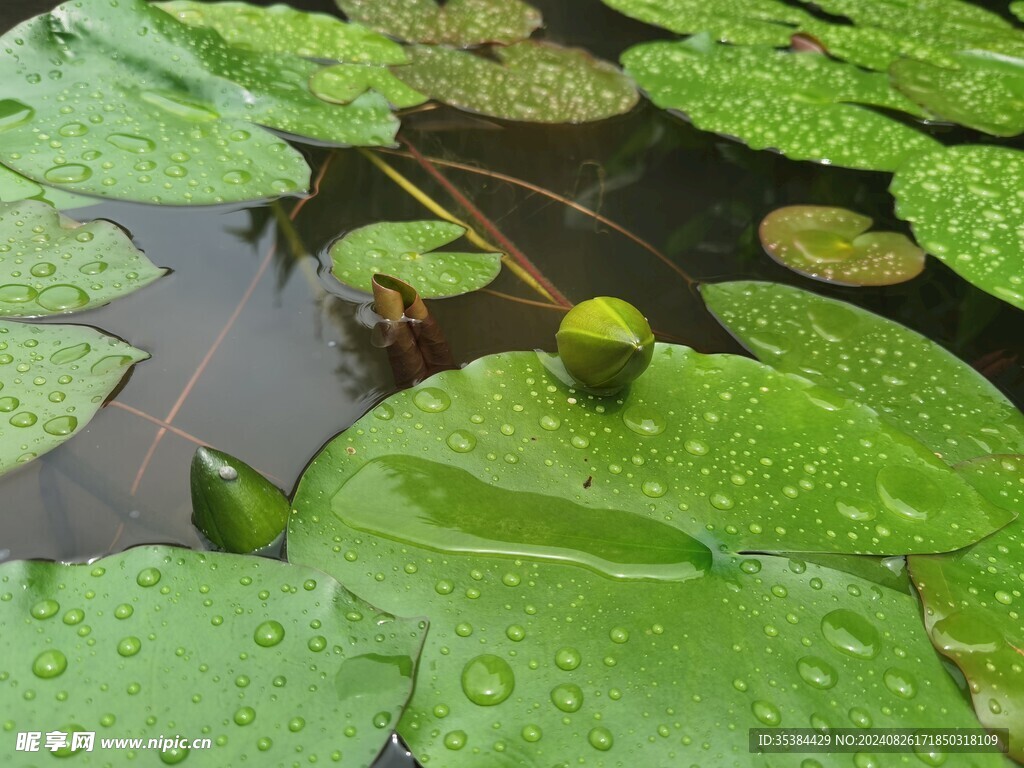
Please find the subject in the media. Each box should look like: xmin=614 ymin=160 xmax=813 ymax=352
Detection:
xmin=0 ymin=0 xmax=1024 ymax=765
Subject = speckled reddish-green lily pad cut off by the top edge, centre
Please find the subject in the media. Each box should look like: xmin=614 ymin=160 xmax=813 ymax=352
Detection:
xmin=335 ymin=0 xmax=541 ymax=47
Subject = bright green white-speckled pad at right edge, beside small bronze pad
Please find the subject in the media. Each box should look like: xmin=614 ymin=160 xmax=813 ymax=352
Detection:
xmin=889 ymin=145 xmax=1024 ymax=313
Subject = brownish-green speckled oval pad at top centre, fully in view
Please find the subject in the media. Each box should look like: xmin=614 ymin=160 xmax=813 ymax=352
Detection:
xmin=393 ymin=41 xmax=638 ymax=123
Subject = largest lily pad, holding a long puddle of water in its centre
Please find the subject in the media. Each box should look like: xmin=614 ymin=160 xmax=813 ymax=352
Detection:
xmin=289 ymin=345 xmax=1006 ymax=768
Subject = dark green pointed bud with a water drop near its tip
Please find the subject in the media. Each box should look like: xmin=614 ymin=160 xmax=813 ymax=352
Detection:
xmin=190 ymin=447 xmax=289 ymax=554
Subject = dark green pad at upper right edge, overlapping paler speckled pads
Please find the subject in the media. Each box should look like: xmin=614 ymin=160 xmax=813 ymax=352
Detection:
xmin=889 ymin=51 xmax=1024 ymax=136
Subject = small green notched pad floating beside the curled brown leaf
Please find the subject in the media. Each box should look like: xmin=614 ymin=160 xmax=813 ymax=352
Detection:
xmin=331 ymin=221 xmax=502 ymax=299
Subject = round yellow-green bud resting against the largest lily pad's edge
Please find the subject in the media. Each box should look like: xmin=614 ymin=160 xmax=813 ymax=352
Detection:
xmin=555 ymin=296 xmax=654 ymax=394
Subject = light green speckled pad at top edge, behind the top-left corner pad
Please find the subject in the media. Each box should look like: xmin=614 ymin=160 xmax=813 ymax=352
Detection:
xmin=155 ymin=0 xmax=408 ymax=65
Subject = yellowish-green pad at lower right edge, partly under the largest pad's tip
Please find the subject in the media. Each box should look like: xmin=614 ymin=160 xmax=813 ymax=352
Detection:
xmin=909 ymin=456 xmax=1024 ymax=762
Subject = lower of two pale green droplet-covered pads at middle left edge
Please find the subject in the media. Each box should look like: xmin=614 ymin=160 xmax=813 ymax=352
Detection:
xmin=0 ymin=319 xmax=150 ymax=474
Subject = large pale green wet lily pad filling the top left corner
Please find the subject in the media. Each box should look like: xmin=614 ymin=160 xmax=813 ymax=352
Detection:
xmin=0 ymin=0 xmax=397 ymax=205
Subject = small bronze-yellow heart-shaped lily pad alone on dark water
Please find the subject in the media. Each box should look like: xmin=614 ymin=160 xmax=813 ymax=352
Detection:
xmin=759 ymin=206 xmax=925 ymax=286
